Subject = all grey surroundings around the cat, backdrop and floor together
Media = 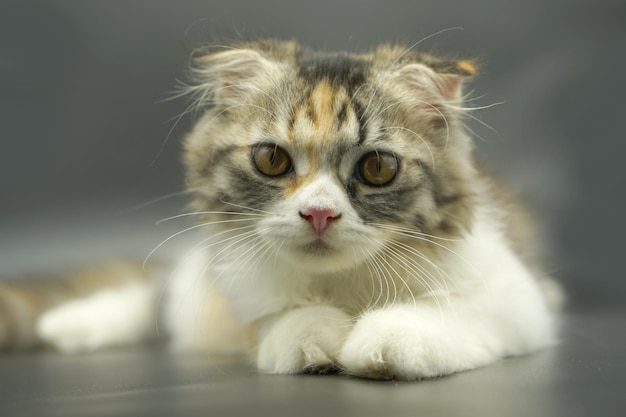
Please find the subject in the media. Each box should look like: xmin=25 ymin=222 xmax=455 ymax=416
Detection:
xmin=0 ymin=0 xmax=626 ymax=417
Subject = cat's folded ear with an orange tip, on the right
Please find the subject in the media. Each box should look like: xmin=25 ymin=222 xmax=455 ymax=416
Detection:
xmin=397 ymin=60 xmax=478 ymax=104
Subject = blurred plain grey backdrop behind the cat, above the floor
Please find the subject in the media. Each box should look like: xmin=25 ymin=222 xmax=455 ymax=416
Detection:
xmin=0 ymin=0 xmax=626 ymax=309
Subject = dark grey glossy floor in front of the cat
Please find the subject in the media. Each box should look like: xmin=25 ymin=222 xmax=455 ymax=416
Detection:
xmin=0 ymin=311 xmax=626 ymax=417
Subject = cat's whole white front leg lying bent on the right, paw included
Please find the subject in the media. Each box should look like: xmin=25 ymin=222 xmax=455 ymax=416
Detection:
xmin=339 ymin=249 xmax=555 ymax=380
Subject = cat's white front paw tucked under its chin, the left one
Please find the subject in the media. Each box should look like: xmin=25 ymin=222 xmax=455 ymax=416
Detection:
xmin=257 ymin=306 xmax=352 ymax=374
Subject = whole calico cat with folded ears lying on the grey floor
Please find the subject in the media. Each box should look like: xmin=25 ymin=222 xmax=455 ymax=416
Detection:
xmin=0 ymin=40 xmax=562 ymax=380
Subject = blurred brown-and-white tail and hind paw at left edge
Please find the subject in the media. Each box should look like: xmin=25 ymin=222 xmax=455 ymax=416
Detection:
xmin=0 ymin=263 xmax=157 ymax=351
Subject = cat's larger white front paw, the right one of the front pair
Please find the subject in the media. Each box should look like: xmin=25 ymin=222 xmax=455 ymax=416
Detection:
xmin=339 ymin=310 xmax=495 ymax=380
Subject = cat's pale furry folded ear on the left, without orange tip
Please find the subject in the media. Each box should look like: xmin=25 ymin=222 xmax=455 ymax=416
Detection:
xmin=192 ymin=47 xmax=281 ymax=106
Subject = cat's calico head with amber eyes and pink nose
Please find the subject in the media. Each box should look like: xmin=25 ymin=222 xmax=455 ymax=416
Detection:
xmin=185 ymin=41 xmax=475 ymax=270
